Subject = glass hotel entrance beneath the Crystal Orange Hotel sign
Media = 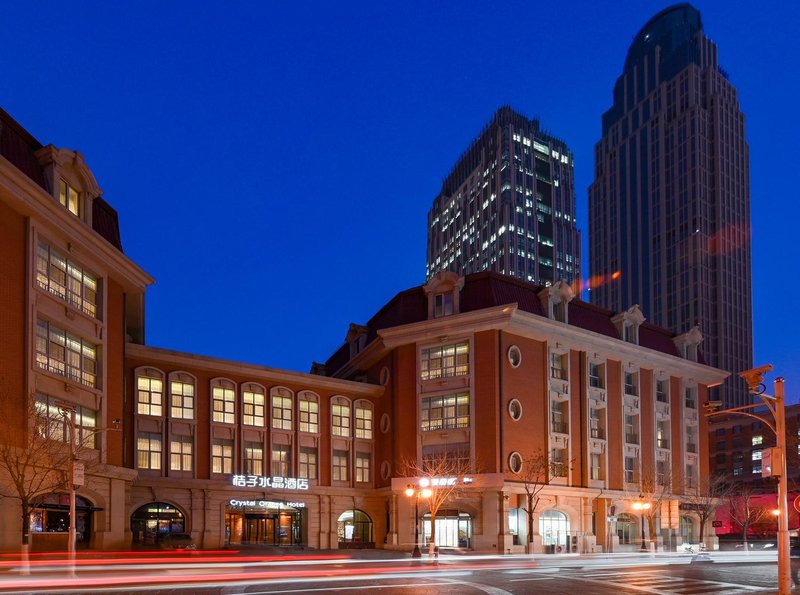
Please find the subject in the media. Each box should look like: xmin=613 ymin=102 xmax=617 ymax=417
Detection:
xmin=225 ymin=500 xmax=305 ymax=545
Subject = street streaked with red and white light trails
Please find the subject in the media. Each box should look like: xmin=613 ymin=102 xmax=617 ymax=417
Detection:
xmin=0 ymin=551 xmax=800 ymax=595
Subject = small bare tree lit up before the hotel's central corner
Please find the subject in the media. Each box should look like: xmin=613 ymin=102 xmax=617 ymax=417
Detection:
xmin=400 ymin=450 xmax=474 ymax=558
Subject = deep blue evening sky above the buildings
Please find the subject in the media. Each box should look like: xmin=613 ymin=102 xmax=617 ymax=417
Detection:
xmin=0 ymin=0 xmax=800 ymax=401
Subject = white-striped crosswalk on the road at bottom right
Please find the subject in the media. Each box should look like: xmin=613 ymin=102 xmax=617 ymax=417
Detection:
xmin=570 ymin=570 xmax=775 ymax=595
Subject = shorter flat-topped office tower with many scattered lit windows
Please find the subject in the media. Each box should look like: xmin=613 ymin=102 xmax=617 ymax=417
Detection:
xmin=427 ymin=107 xmax=581 ymax=285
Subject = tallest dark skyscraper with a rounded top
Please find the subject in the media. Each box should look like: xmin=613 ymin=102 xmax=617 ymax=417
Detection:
xmin=589 ymin=4 xmax=753 ymax=406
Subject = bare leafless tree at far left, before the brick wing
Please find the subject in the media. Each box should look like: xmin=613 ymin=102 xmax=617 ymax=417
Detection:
xmin=0 ymin=394 xmax=70 ymax=559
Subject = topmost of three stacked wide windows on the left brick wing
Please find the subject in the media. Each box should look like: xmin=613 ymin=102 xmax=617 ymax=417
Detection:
xmin=36 ymin=242 xmax=98 ymax=318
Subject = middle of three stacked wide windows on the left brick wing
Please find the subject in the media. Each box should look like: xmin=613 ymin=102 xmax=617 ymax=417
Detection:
xmin=36 ymin=319 xmax=98 ymax=387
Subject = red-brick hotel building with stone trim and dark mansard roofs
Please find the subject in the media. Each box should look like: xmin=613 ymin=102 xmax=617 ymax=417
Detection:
xmin=0 ymin=106 xmax=727 ymax=553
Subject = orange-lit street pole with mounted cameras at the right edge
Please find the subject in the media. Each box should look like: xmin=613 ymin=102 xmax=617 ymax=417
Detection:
xmin=705 ymin=364 xmax=792 ymax=595
